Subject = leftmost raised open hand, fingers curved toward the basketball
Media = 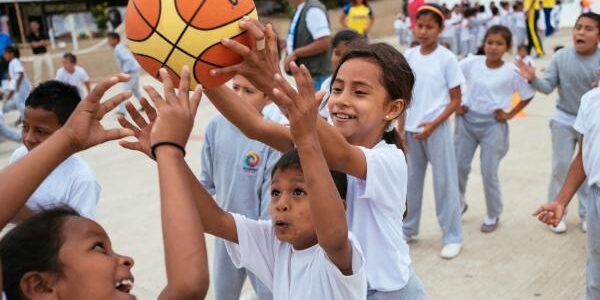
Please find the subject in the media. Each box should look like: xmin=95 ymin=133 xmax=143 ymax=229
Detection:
xmin=60 ymin=74 xmax=133 ymax=152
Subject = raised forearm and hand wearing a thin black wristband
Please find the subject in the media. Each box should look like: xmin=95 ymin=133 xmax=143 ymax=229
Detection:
xmin=144 ymin=67 xmax=209 ymax=300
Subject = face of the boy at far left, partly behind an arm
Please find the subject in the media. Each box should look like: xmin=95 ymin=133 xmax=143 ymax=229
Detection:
xmin=21 ymin=106 xmax=62 ymax=151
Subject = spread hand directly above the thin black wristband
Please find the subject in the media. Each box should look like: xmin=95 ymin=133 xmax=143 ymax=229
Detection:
xmin=145 ymin=66 xmax=202 ymax=156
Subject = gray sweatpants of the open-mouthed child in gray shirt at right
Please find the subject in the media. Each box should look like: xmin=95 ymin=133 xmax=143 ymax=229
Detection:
xmin=548 ymin=120 xmax=590 ymax=220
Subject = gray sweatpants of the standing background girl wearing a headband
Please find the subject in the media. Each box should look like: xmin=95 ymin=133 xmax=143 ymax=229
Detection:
xmin=403 ymin=121 xmax=463 ymax=244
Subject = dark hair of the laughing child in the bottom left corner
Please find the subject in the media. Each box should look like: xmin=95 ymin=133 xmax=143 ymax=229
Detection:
xmin=0 ymin=206 xmax=80 ymax=300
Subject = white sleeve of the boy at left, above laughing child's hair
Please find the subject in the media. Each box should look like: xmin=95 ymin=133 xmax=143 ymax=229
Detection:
xmin=68 ymin=179 xmax=101 ymax=220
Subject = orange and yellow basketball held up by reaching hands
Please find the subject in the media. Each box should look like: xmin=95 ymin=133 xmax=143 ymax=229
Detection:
xmin=125 ymin=0 xmax=258 ymax=88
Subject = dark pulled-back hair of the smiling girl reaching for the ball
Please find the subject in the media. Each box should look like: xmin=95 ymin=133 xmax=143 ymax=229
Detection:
xmin=332 ymin=43 xmax=415 ymax=153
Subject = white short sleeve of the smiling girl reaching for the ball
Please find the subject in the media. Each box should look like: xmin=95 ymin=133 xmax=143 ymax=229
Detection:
xmin=359 ymin=144 xmax=407 ymax=211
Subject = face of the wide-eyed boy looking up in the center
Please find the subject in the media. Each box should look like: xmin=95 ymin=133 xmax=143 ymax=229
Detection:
xmin=269 ymin=168 xmax=317 ymax=250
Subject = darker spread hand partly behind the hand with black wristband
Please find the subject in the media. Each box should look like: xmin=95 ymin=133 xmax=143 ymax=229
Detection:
xmin=117 ymin=98 xmax=157 ymax=159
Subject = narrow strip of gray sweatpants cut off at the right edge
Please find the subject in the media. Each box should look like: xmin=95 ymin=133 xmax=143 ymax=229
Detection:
xmin=585 ymin=185 xmax=600 ymax=300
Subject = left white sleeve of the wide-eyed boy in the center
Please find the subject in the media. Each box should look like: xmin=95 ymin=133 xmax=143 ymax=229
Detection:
xmin=225 ymin=214 xmax=277 ymax=290
